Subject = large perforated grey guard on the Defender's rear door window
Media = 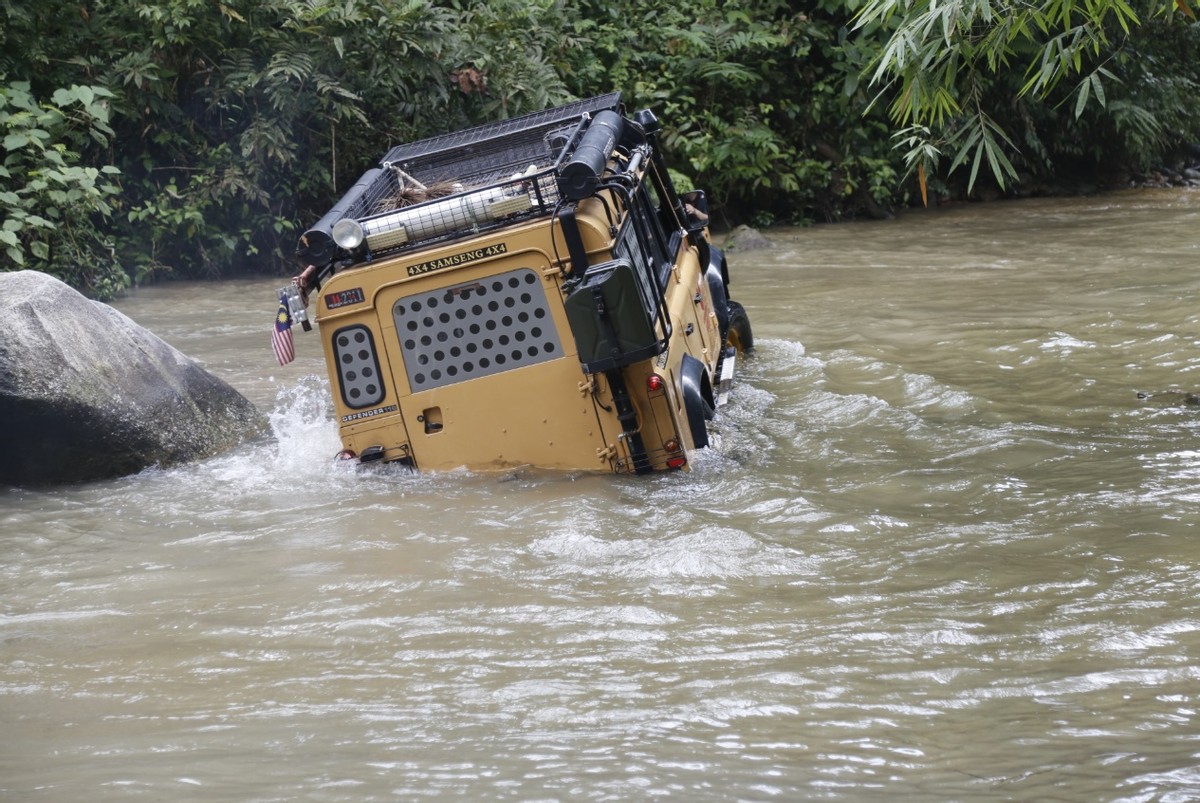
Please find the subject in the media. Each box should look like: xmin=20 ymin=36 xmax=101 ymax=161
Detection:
xmin=392 ymin=268 xmax=563 ymax=392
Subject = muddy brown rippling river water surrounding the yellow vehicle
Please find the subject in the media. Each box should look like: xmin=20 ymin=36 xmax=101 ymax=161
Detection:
xmin=0 ymin=190 xmax=1200 ymax=801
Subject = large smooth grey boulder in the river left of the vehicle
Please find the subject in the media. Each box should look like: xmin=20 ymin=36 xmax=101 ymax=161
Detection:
xmin=0 ymin=270 xmax=265 ymax=485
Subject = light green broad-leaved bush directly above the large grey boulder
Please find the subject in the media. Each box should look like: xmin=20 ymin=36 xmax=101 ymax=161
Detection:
xmin=0 ymin=82 xmax=128 ymax=298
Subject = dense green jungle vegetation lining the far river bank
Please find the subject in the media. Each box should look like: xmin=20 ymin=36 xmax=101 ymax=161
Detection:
xmin=0 ymin=0 xmax=1200 ymax=298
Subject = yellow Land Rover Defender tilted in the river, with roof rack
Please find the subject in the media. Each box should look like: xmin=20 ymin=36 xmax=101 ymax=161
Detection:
xmin=296 ymin=94 xmax=752 ymax=474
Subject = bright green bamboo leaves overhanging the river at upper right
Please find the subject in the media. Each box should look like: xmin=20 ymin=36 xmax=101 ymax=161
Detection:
xmin=857 ymin=0 xmax=1196 ymax=192
